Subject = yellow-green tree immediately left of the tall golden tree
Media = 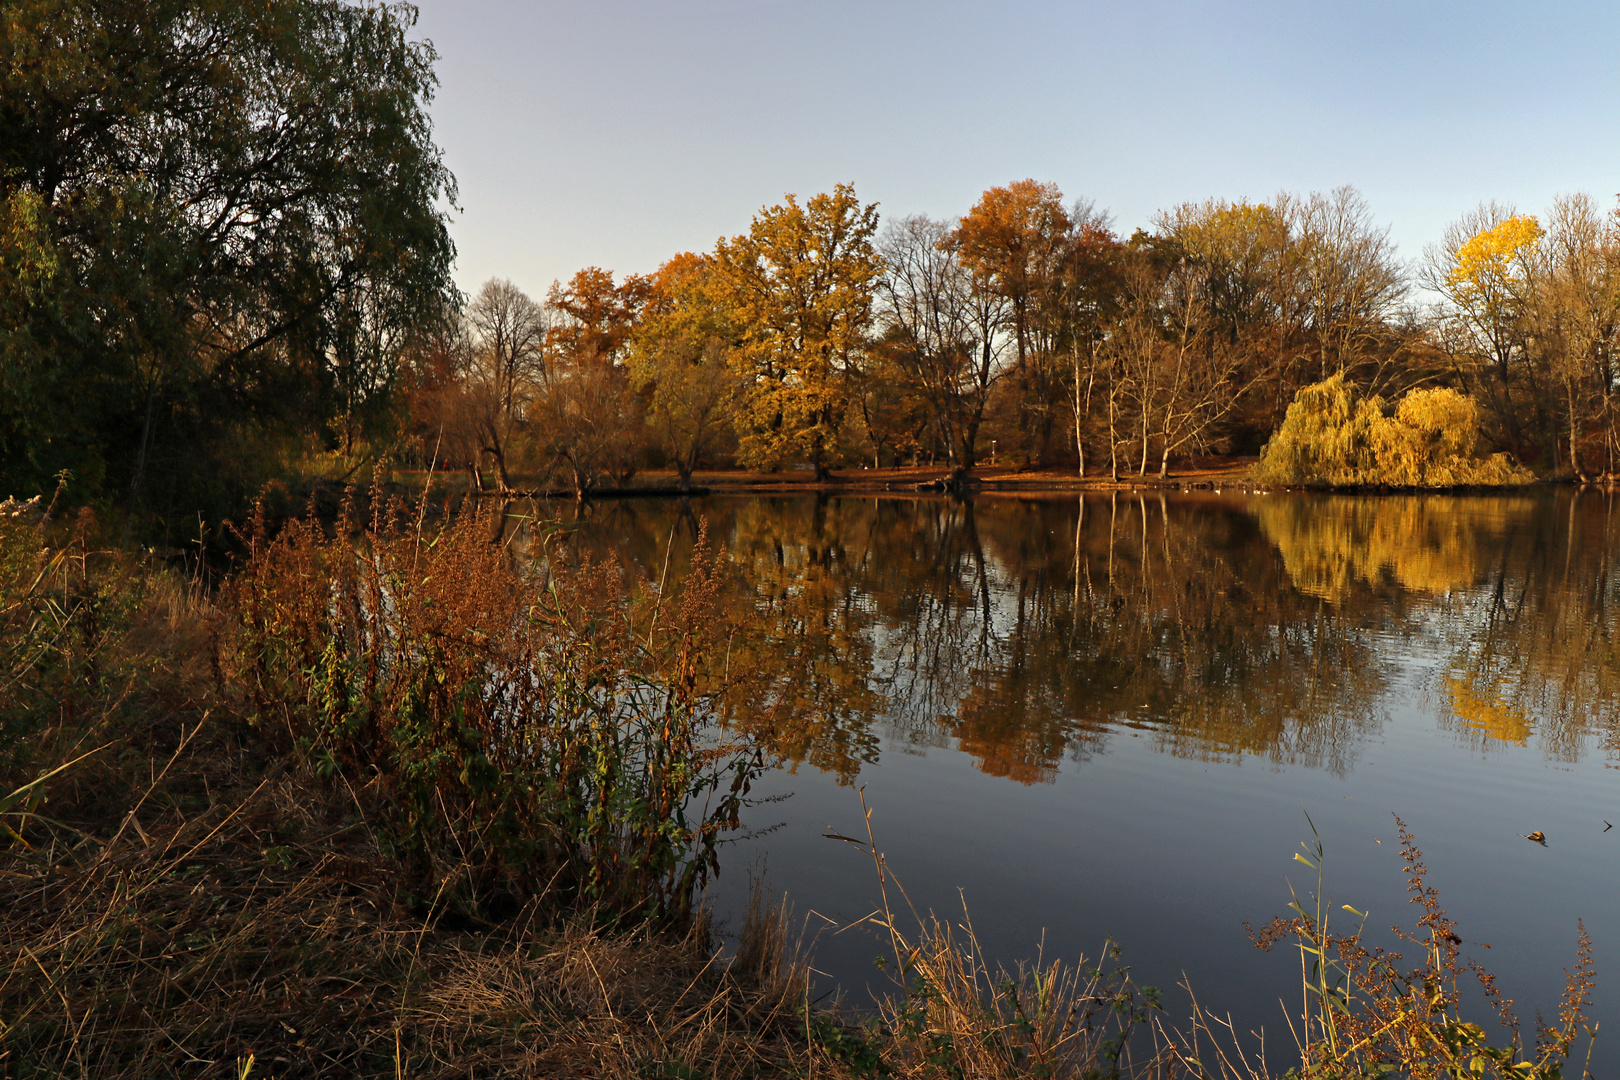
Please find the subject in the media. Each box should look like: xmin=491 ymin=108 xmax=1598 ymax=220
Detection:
xmin=627 ymin=253 xmax=737 ymax=489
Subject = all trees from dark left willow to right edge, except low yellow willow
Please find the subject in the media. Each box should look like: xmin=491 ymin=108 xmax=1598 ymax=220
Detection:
xmin=0 ymin=0 xmax=1620 ymax=528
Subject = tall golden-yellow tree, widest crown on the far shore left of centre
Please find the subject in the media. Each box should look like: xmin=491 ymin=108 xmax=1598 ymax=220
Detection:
xmin=713 ymin=185 xmax=881 ymax=478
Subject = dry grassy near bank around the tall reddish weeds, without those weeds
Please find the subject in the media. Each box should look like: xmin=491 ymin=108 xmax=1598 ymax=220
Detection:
xmin=0 ymin=515 xmax=1172 ymax=1080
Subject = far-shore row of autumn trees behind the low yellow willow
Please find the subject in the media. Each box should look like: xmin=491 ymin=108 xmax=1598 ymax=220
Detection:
xmin=411 ymin=180 xmax=1620 ymax=492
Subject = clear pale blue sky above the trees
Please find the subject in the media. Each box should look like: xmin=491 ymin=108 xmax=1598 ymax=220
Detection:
xmin=416 ymin=0 xmax=1620 ymax=296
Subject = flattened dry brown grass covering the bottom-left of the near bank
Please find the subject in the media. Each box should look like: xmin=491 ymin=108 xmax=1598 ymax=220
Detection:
xmin=0 ymin=757 xmax=812 ymax=1077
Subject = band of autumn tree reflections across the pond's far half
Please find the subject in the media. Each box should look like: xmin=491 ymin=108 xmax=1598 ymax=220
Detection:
xmin=541 ymin=492 xmax=1620 ymax=784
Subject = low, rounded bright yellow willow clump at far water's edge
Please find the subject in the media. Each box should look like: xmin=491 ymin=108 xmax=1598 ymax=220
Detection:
xmin=1254 ymin=374 xmax=1534 ymax=487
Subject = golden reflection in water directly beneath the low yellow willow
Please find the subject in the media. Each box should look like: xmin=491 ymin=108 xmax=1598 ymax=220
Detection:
xmin=1254 ymin=495 xmax=1536 ymax=602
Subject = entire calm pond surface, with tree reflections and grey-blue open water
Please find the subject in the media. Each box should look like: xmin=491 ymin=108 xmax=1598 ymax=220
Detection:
xmin=554 ymin=491 xmax=1620 ymax=1077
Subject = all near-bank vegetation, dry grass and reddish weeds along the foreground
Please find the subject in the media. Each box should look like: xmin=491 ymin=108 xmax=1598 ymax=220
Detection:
xmin=0 ymin=498 xmax=1596 ymax=1080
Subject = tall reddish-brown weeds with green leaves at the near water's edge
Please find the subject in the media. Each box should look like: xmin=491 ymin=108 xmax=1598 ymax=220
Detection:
xmin=230 ymin=497 xmax=760 ymax=918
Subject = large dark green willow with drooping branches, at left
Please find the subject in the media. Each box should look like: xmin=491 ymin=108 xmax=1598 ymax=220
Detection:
xmin=0 ymin=0 xmax=455 ymax=508
